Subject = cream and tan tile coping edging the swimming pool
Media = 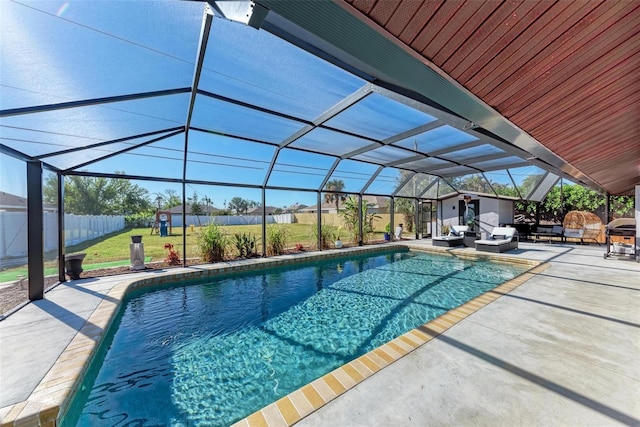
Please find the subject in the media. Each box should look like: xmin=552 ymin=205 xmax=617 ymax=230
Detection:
xmin=0 ymin=244 xmax=548 ymax=427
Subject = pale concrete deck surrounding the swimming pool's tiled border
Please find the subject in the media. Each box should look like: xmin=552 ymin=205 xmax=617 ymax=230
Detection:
xmin=0 ymin=240 xmax=640 ymax=426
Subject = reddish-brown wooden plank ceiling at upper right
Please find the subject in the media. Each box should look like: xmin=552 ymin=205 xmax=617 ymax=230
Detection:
xmin=344 ymin=0 xmax=640 ymax=194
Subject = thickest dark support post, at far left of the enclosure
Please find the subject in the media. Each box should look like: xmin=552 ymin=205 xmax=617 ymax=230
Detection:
xmin=27 ymin=161 xmax=44 ymax=301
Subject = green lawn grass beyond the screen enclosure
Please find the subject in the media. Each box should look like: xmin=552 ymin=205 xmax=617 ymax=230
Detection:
xmin=0 ymin=224 xmax=382 ymax=283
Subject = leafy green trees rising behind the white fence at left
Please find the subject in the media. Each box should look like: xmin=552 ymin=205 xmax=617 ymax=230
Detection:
xmin=43 ymin=171 xmax=153 ymax=215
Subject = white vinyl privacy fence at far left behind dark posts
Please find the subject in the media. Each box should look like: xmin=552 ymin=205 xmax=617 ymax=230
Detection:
xmin=0 ymin=212 xmax=124 ymax=259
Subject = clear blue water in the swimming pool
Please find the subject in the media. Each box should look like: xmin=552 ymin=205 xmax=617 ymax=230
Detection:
xmin=63 ymin=252 xmax=525 ymax=426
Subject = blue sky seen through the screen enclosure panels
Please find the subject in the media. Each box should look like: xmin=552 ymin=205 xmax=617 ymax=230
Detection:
xmin=0 ymin=1 xmax=544 ymax=207
